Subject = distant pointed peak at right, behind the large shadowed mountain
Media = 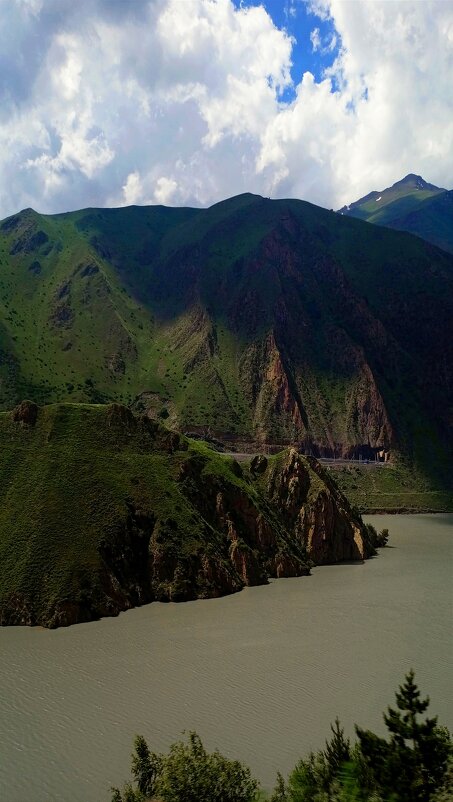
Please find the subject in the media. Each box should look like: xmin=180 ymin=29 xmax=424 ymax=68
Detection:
xmin=339 ymin=173 xmax=453 ymax=253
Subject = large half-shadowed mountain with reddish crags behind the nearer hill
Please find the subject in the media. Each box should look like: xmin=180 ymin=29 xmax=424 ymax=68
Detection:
xmin=0 ymin=190 xmax=453 ymax=483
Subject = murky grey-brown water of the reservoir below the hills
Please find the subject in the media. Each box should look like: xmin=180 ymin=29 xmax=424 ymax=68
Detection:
xmin=0 ymin=515 xmax=453 ymax=802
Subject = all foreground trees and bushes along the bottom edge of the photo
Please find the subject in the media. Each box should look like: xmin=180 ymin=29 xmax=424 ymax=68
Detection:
xmin=112 ymin=671 xmax=453 ymax=802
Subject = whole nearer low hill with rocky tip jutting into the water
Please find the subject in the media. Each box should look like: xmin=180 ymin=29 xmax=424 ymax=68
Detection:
xmin=0 ymin=402 xmax=374 ymax=627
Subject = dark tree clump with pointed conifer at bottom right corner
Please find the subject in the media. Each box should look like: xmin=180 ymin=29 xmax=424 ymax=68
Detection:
xmin=274 ymin=671 xmax=453 ymax=802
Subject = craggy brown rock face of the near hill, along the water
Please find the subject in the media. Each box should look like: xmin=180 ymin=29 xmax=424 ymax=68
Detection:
xmin=5 ymin=444 xmax=374 ymax=627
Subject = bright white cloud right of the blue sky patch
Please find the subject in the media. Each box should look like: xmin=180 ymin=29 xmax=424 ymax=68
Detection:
xmin=258 ymin=0 xmax=453 ymax=207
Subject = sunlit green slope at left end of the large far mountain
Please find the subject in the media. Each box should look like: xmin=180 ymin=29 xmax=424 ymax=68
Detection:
xmin=1 ymin=213 xmax=152 ymax=400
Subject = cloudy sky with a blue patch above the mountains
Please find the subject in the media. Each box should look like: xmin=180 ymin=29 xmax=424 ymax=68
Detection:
xmin=0 ymin=0 xmax=453 ymax=218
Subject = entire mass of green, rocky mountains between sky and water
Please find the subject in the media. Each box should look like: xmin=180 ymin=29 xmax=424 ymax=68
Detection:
xmin=0 ymin=179 xmax=453 ymax=626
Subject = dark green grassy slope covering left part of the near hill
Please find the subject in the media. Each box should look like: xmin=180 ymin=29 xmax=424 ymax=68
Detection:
xmin=0 ymin=405 xmax=200 ymax=615
